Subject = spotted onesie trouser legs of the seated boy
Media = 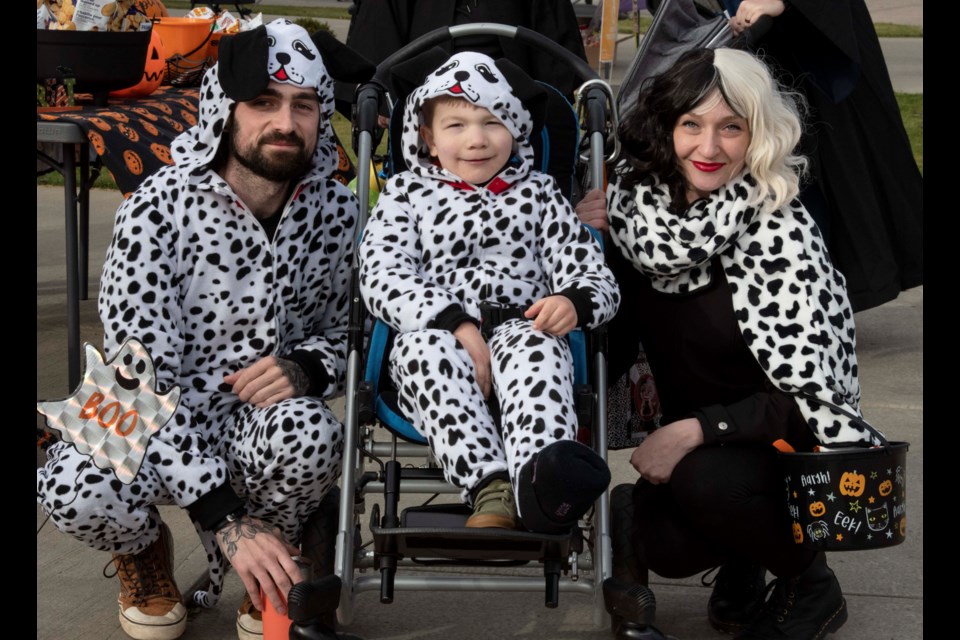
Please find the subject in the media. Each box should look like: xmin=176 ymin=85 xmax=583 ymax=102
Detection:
xmin=390 ymin=320 xmax=577 ymax=502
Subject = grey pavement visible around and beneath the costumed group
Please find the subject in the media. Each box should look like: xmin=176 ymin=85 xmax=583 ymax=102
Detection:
xmin=36 ymin=0 xmax=923 ymax=640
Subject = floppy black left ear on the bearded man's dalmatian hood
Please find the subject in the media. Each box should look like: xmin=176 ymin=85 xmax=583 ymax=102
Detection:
xmin=217 ymin=26 xmax=270 ymax=102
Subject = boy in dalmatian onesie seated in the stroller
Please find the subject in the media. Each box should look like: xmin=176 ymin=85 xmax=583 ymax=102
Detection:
xmin=359 ymin=51 xmax=619 ymax=533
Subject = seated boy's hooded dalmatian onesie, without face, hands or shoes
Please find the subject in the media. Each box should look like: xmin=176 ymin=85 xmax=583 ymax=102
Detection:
xmin=359 ymin=53 xmax=619 ymax=498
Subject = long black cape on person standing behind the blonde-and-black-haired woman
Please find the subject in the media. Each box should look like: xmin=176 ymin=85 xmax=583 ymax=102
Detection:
xmin=760 ymin=0 xmax=923 ymax=311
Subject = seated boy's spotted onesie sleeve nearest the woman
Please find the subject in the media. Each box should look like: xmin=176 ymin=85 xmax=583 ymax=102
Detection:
xmin=535 ymin=175 xmax=620 ymax=328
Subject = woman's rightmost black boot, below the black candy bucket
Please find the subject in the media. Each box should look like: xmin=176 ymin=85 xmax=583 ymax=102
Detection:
xmin=736 ymin=553 xmax=847 ymax=640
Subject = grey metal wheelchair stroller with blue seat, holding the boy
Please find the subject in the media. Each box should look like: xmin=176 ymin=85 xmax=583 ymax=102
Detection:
xmin=318 ymin=23 xmax=664 ymax=627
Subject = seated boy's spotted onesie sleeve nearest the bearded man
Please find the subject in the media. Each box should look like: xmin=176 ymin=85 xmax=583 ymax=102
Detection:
xmin=360 ymin=179 xmax=461 ymax=332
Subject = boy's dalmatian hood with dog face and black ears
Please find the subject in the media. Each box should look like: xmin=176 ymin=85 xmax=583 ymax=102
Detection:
xmin=394 ymin=51 xmax=546 ymax=182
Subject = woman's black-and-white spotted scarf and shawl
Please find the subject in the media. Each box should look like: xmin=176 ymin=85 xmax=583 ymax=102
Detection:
xmin=607 ymin=174 xmax=873 ymax=445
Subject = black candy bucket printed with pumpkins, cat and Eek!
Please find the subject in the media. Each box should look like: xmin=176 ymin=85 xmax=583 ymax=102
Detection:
xmin=779 ymin=396 xmax=910 ymax=551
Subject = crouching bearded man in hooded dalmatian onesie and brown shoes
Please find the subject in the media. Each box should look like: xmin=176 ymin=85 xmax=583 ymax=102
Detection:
xmin=37 ymin=20 xmax=369 ymax=639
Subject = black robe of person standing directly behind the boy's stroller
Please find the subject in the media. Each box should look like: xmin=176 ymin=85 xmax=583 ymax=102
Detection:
xmin=347 ymin=0 xmax=586 ymax=96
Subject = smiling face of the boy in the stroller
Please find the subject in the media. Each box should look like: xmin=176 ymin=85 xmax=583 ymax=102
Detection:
xmin=420 ymin=100 xmax=514 ymax=185
